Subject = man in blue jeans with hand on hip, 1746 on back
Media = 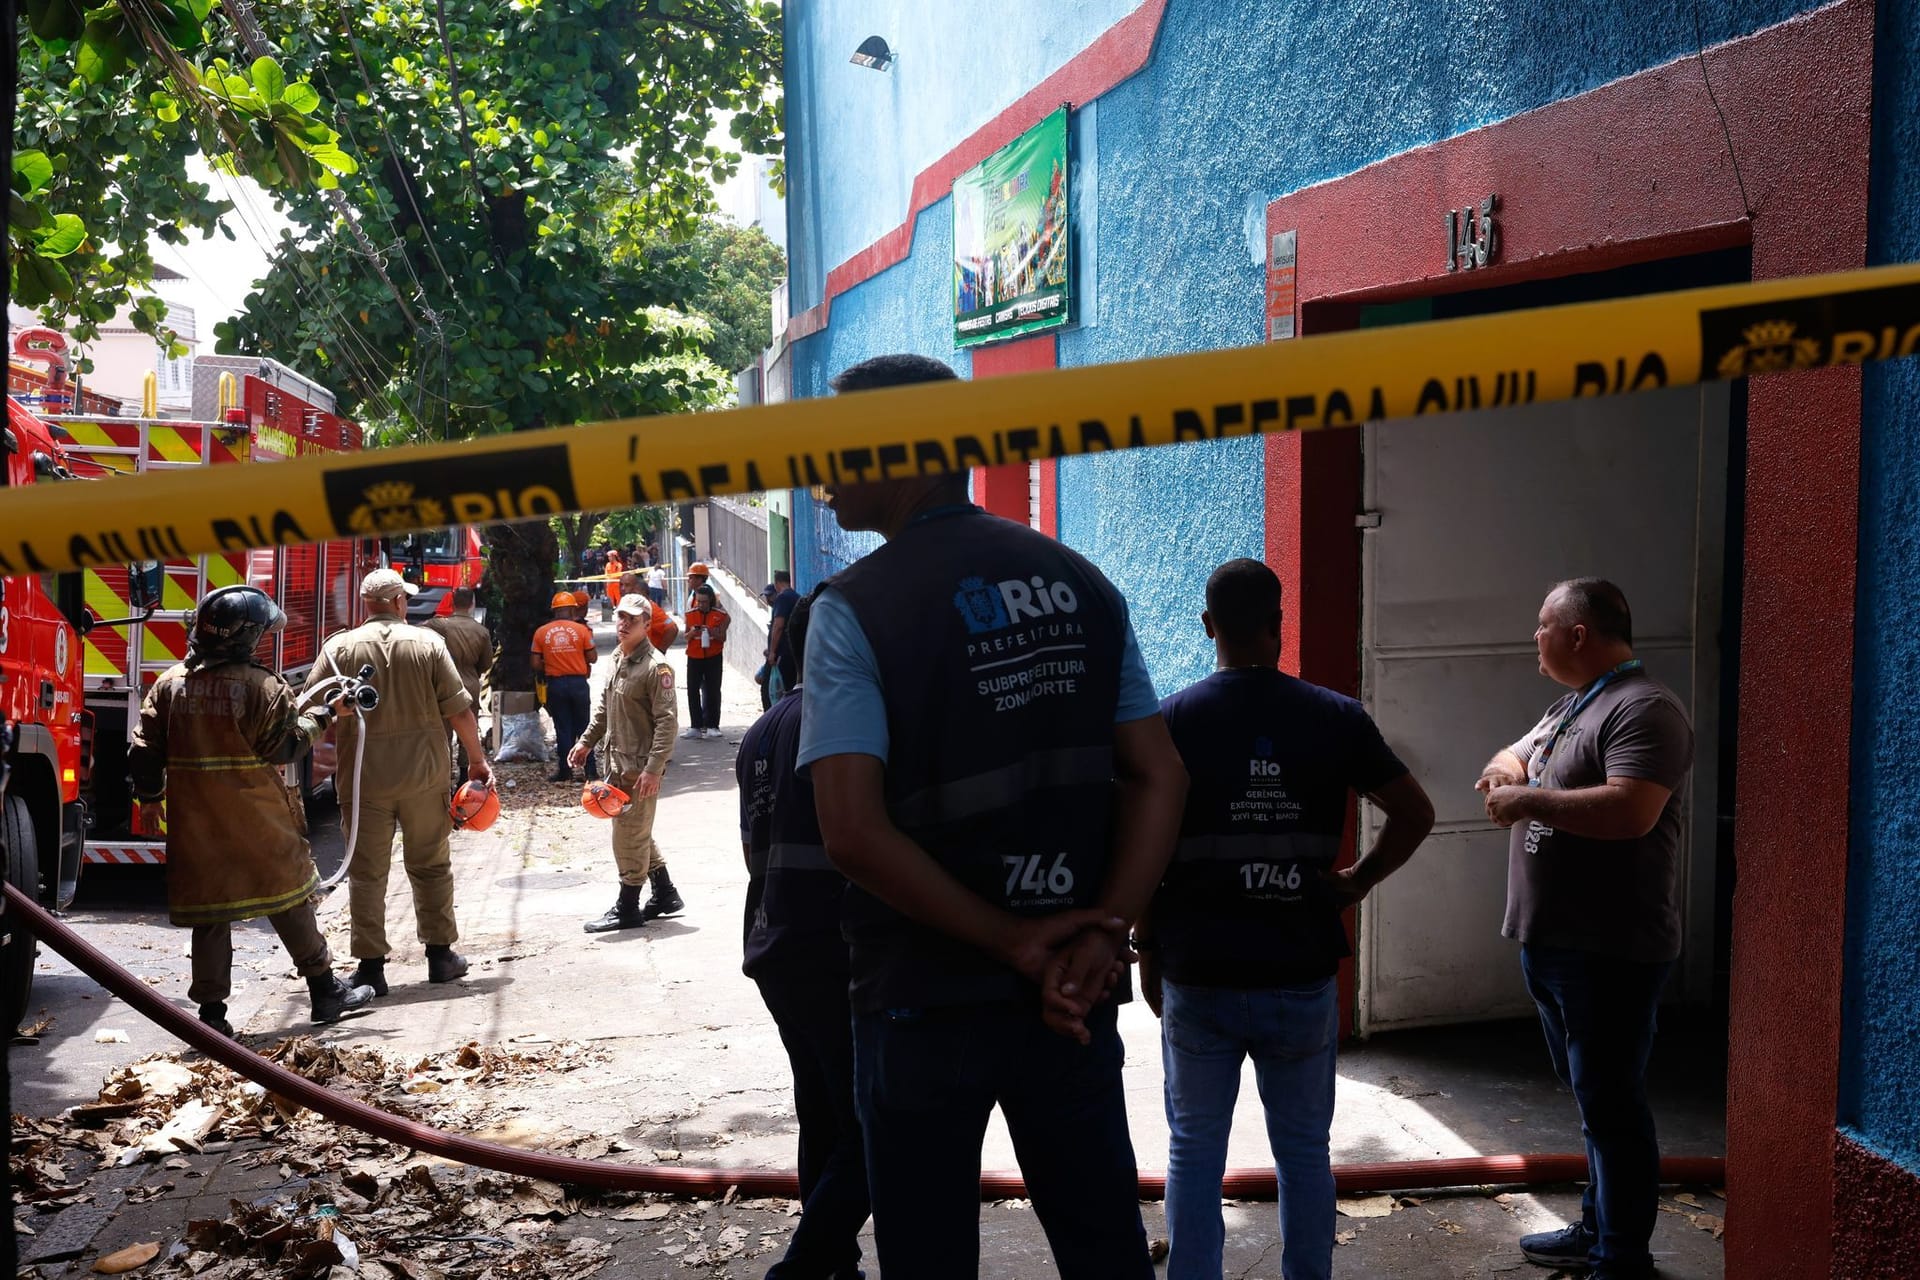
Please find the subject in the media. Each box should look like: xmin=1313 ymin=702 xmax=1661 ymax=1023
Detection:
xmin=1135 ymin=560 xmax=1434 ymax=1280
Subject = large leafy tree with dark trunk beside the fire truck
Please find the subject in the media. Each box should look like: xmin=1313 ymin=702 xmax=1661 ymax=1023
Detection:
xmin=221 ymin=0 xmax=781 ymax=702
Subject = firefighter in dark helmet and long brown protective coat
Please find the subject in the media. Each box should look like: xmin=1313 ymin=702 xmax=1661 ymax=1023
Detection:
xmin=129 ymin=587 xmax=372 ymax=1036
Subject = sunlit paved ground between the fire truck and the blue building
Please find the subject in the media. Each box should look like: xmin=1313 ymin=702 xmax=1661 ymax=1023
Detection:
xmin=12 ymin=628 xmax=1724 ymax=1280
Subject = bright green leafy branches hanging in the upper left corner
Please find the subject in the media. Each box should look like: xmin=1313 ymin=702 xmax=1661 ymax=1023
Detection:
xmin=8 ymin=0 xmax=355 ymax=344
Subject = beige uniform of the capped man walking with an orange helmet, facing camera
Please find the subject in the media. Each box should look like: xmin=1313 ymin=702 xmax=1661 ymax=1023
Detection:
xmin=580 ymin=643 xmax=680 ymax=885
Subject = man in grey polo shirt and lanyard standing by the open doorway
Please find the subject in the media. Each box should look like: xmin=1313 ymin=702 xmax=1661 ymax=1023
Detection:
xmin=1475 ymin=578 xmax=1693 ymax=1280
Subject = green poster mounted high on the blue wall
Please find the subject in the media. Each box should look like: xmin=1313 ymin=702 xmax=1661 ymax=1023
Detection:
xmin=954 ymin=106 xmax=1073 ymax=347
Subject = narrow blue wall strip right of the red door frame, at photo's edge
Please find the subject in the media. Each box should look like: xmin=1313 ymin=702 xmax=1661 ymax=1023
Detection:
xmin=1839 ymin=0 xmax=1920 ymax=1174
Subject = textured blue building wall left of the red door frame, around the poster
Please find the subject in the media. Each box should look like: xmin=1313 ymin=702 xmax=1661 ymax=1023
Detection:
xmin=787 ymin=0 xmax=1820 ymax=691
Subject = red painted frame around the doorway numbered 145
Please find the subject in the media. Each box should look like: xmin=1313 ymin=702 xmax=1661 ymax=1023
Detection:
xmin=1267 ymin=0 xmax=1873 ymax=1280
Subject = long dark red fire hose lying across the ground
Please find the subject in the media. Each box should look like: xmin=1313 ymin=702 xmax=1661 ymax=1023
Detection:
xmin=6 ymin=885 xmax=1726 ymax=1199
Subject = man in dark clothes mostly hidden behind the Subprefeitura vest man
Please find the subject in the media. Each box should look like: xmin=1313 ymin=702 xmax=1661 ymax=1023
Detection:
xmin=733 ymin=601 xmax=868 ymax=1280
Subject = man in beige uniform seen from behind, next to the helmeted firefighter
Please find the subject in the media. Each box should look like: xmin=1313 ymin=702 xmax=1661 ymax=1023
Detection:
xmin=307 ymin=568 xmax=493 ymax=996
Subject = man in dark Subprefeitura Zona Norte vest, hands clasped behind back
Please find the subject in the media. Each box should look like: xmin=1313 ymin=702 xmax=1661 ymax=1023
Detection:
xmin=799 ymin=355 xmax=1187 ymax=1280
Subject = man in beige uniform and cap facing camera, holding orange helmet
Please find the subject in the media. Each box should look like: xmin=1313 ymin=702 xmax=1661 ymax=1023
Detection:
xmin=566 ymin=595 xmax=685 ymax=933
